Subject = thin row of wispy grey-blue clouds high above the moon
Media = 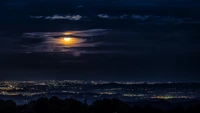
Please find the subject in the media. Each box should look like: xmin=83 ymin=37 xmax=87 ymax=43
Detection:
xmin=30 ymin=14 xmax=199 ymax=24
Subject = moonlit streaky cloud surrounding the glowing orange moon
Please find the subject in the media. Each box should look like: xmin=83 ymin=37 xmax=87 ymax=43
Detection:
xmin=21 ymin=29 xmax=106 ymax=52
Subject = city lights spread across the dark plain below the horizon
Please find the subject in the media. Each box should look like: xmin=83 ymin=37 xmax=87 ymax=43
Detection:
xmin=0 ymin=80 xmax=200 ymax=104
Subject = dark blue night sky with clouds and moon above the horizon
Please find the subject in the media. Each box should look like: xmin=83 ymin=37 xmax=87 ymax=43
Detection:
xmin=0 ymin=0 xmax=200 ymax=82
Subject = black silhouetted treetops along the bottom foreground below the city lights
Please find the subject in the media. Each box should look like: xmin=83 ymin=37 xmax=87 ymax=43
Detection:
xmin=0 ymin=97 xmax=200 ymax=113
